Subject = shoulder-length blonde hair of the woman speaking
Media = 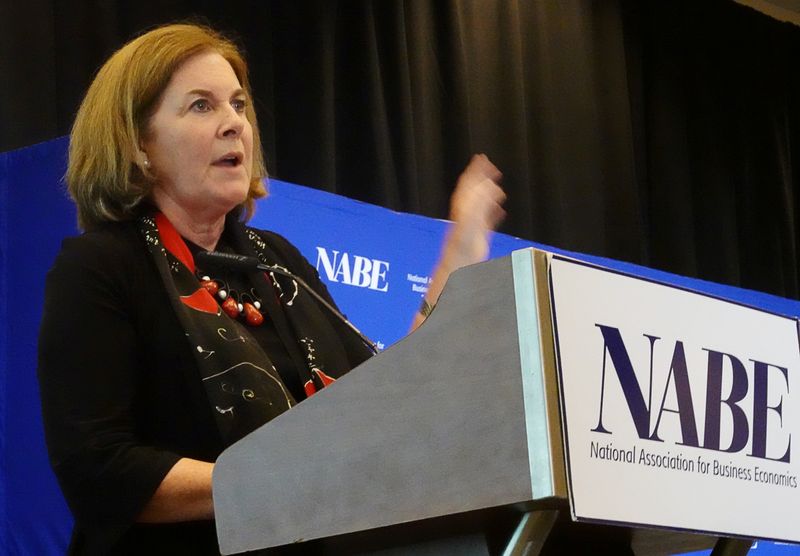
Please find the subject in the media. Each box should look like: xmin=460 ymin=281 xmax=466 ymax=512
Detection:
xmin=66 ymin=24 xmax=267 ymax=229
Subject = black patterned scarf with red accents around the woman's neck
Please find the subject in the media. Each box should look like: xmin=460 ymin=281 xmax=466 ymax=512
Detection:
xmin=139 ymin=213 xmax=370 ymax=445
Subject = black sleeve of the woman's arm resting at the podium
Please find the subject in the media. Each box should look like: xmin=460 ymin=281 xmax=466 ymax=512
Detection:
xmin=38 ymin=231 xmax=180 ymax=544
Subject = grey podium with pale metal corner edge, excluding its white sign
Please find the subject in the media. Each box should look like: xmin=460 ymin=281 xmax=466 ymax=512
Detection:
xmin=214 ymin=250 xmax=788 ymax=554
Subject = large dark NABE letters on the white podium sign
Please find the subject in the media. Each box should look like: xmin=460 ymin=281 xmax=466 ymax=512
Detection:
xmin=591 ymin=324 xmax=792 ymax=463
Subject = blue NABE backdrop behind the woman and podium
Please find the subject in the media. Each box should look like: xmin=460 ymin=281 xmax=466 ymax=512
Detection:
xmin=0 ymin=138 xmax=800 ymax=555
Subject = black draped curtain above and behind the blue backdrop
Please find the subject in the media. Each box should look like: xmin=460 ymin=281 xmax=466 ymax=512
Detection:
xmin=0 ymin=0 xmax=800 ymax=297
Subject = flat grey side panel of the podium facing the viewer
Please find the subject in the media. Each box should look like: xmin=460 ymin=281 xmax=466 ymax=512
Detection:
xmin=214 ymin=257 xmax=532 ymax=554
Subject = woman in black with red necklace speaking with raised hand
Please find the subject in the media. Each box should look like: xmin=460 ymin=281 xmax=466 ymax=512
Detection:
xmin=39 ymin=25 xmax=504 ymax=554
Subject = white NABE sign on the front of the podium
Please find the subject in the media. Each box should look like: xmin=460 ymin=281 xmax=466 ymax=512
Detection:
xmin=550 ymin=256 xmax=800 ymax=542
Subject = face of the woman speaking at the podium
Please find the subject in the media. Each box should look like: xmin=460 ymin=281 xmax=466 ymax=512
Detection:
xmin=142 ymin=52 xmax=253 ymax=221
